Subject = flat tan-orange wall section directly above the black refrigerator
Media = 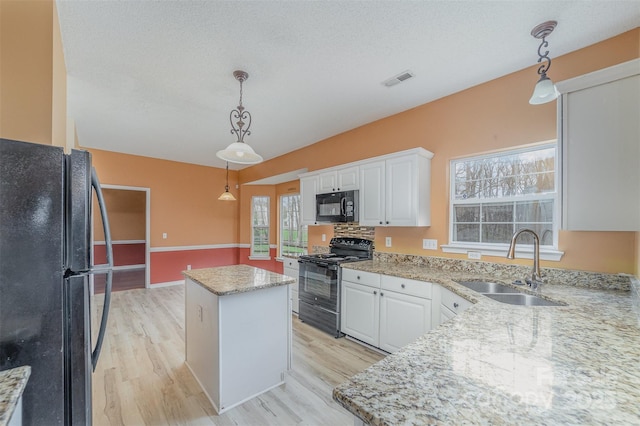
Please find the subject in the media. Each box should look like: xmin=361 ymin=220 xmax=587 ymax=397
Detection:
xmin=0 ymin=0 xmax=54 ymax=145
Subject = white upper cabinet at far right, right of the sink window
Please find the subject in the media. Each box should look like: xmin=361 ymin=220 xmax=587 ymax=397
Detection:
xmin=557 ymin=59 xmax=640 ymax=231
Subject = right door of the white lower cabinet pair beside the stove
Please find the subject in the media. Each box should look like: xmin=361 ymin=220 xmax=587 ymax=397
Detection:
xmin=380 ymin=290 xmax=431 ymax=352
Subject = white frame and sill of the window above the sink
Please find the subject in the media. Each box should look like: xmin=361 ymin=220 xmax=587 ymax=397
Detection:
xmin=441 ymin=139 xmax=564 ymax=261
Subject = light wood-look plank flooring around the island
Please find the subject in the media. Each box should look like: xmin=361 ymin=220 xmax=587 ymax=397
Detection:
xmin=92 ymin=286 xmax=383 ymax=426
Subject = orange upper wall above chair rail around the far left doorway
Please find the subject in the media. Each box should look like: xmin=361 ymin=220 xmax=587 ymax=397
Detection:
xmin=89 ymin=148 xmax=239 ymax=248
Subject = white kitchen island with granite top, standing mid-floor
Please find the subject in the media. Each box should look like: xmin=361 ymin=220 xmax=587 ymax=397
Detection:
xmin=183 ymin=265 xmax=295 ymax=414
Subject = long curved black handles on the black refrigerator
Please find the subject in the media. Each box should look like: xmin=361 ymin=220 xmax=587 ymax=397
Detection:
xmin=91 ymin=167 xmax=113 ymax=371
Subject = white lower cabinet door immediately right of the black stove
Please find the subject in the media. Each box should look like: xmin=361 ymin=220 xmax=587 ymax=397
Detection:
xmin=341 ymin=281 xmax=380 ymax=347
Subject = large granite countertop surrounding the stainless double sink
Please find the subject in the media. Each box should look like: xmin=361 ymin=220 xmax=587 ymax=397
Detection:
xmin=333 ymin=260 xmax=640 ymax=425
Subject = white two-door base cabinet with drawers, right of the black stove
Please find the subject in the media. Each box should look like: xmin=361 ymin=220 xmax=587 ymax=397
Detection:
xmin=341 ymin=269 xmax=431 ymax=352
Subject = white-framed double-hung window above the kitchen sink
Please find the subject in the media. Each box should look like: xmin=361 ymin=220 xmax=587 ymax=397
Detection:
xmin=443 ymin=143 xmax=562 ymax=260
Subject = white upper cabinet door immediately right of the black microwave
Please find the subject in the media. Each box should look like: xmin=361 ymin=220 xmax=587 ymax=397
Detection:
xmin=360 ymin=161 xmax=386 ymax=226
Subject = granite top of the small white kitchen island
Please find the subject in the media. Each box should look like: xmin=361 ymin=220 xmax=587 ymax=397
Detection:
xmin=182 ymin=265 xmax=296 ymax=296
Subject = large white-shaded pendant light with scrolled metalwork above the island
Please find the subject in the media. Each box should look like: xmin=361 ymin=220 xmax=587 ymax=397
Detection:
xmin=216 ymin=70 xmax=262 ymax=168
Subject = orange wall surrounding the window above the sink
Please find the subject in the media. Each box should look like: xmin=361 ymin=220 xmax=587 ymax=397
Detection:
xmin=239 ymin=28 xmax=640 ymax=273
